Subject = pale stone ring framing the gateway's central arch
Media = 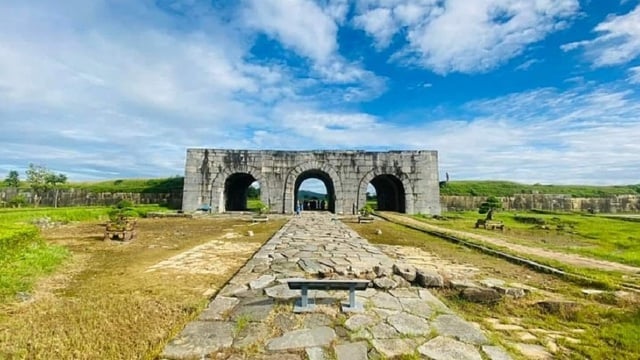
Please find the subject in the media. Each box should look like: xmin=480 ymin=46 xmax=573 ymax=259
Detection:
xmin=282 ymin=161 xmax=343 ymax=213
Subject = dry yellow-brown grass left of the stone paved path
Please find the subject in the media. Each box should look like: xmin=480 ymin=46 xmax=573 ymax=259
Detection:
xmin=0 ymin=215 xmax=284 ymax=359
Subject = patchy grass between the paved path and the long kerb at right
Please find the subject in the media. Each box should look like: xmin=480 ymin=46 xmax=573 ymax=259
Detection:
xmin=350 ymin=221 xmax=640 ymax=359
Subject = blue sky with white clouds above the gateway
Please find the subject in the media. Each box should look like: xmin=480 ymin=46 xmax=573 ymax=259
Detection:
xmin=0 ymin=0 xmax=640 ymax=184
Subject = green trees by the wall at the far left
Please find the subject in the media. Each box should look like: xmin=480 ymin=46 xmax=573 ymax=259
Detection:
xmin=4 ymin=163 xmax=67 ymax=207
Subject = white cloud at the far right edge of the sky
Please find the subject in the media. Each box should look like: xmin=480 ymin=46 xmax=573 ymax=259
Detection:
xmin=562 ymin=5 xmax=640 ymax=67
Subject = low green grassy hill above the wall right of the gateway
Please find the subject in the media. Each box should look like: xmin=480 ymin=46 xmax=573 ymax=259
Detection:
xmin=440 ymin=180 xmax=640 ymax=198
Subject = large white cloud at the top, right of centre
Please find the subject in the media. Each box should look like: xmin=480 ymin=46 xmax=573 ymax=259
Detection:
xmin=355 ymin=0 xmax=579 ymax=74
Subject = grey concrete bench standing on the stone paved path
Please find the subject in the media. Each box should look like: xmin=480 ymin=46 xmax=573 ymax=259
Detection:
xmin=287 ymin=279 xmax=370 ymax=313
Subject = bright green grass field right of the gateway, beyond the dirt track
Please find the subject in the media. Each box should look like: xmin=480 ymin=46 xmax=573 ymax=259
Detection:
xmin=418 ymin=211 xmax=640 ymax=266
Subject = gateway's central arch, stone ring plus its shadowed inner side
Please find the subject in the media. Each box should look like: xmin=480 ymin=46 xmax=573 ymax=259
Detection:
xmin=282 ymin=161 xmax=343 ymax=213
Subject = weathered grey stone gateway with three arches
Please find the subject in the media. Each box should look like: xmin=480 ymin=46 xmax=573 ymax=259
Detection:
xmin=182 ymin=149 xmax=440 ymax=214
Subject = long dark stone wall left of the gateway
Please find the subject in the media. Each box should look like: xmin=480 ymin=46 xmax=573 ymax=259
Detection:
xmin=0 ymin=188 xmax=182 ymax=209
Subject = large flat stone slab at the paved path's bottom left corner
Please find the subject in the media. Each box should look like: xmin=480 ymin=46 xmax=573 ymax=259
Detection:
xmin=160 ymin=321 xmax=234 ymax=360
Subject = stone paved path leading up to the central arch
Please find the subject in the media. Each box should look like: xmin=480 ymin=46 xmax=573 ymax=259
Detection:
xmin=161 ymin=213 xmax=510 ymax=360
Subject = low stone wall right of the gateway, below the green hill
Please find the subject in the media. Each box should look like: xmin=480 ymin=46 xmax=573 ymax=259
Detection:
xmin=440 ymin=194 xmax=640 ymax=213
